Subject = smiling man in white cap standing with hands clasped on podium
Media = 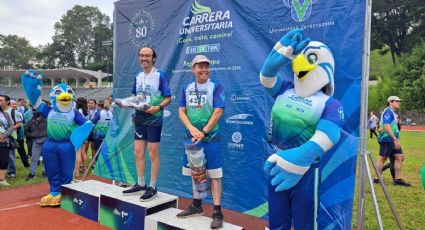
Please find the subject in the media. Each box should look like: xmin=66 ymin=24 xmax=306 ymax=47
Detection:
xmin=177 ymin=55 xmax=224 ymax=229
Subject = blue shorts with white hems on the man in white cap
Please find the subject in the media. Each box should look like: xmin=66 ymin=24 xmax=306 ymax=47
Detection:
xmin=182 ymin=141 xmax=223 ymax=178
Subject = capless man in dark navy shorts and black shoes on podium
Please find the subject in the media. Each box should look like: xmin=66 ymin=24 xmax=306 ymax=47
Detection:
xmin=123 ymin=47 xmax=171 ymax=201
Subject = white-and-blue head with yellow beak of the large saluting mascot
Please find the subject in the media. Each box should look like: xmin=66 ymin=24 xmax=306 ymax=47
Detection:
xmin=292 ymin=41 xmax=335 ymax=97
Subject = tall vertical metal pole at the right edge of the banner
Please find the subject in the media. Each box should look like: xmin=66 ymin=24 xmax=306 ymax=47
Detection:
xmin=357 ymin=0 xmax=372 ymax=229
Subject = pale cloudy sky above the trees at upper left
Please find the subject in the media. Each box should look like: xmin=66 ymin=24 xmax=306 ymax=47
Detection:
xmin=0 ymin=0 xmax=116 ymax=46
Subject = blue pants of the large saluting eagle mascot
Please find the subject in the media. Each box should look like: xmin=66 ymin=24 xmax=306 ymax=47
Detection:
xmin=267 ymin=164 xmax=320 ymax=230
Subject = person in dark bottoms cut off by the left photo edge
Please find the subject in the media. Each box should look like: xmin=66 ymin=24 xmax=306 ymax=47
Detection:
xmin=0 ymin=104 xmax=13 ymax=186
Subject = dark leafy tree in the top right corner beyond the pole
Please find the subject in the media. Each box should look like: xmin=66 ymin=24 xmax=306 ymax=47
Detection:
xmin=372 ymin=0 xmax=425 ymax=65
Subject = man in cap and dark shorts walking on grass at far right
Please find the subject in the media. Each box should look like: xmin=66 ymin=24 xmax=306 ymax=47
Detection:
xmin=374 ymin=96 xmax=410 ymax=186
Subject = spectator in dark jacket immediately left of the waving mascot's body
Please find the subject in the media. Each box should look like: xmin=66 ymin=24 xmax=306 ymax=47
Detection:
xmin=25 ymin=112 xmax=47 ymax=180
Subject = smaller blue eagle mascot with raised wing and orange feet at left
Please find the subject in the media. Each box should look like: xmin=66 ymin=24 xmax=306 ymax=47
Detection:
xmin=21 ymin=70 xmax=94 ymax=207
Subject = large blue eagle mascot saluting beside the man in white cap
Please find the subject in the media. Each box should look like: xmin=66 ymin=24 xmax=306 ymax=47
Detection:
xmin=260 ymin=29 xmax=344 ymax=230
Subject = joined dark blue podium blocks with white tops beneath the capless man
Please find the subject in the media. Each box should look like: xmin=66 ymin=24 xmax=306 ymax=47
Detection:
xmin=61 ymin=180 xmax=177 ymax=229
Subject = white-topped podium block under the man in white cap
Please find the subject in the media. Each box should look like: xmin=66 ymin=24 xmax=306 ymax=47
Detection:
xmin=145 ymin=208 xmax=243 ymax=230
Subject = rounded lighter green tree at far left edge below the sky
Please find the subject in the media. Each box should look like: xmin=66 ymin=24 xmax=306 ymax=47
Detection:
xmin=0 ymin=35 xmax=37 ymax=69
